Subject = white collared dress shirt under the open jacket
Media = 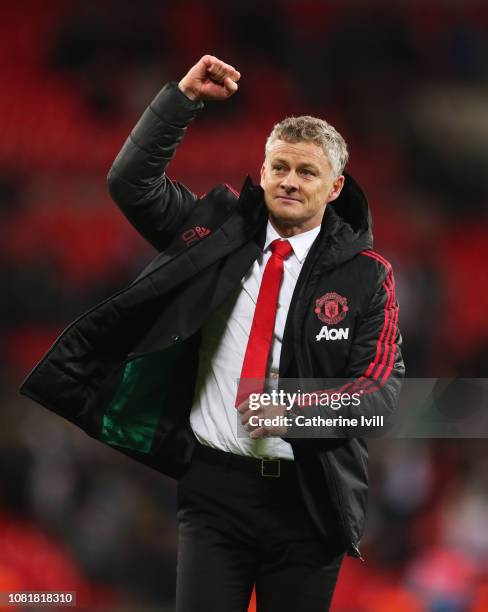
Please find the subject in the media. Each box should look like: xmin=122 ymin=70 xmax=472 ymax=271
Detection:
xmin=190 ymin=221 xmax=320 ymax=459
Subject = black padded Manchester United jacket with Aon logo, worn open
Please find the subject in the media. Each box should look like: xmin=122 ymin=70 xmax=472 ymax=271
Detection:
xmin=21 ymin=84 xmax=404 ymax=556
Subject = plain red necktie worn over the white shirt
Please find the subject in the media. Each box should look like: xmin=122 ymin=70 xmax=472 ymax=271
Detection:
xmin=236 ymin=240 xmax=293 ymax=406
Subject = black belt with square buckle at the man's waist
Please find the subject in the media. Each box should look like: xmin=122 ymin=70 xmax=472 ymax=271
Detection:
xmin=193 ymin=442 xmax=296 ymax=478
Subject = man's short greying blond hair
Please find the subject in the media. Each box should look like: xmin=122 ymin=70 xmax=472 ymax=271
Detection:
xmin=265 ymin=115 xmax=349 ymax=177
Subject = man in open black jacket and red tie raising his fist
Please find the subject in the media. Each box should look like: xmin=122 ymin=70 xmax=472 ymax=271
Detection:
xmin=21 ymin=55 xmax=404 ymax=612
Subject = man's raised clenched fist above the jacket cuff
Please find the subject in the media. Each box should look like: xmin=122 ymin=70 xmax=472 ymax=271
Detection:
xmin=178 ymin=55 xmax=241 ymax=100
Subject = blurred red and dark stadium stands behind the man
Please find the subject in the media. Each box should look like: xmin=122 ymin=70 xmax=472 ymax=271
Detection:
xmin=0 ymin=0 xmax=488 ymax=612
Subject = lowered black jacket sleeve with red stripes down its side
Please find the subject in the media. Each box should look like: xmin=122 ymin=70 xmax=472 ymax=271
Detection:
xmin=286 ymin=260 xmax=405 ymax=438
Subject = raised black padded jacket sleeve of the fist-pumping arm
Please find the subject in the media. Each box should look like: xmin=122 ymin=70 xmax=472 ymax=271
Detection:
xmin=107 ymin=83 xmax=203 ymax=251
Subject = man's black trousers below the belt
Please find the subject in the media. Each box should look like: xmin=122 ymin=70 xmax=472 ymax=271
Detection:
xmin=176 ymin=444 xmax=344 ymax=612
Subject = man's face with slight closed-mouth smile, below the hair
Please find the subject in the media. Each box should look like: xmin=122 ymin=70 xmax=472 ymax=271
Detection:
xmin=261 ymin=140 xmax=344 ymax=236
